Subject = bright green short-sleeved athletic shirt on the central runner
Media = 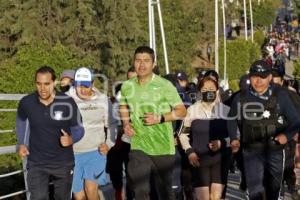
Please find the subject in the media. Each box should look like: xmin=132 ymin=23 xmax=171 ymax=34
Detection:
xmin=120 ymin=74 xmax=182 ymax=155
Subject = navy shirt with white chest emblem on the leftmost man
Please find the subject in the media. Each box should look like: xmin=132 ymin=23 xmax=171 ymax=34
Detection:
xmin=17 ymin=92 xmax=81 ymax=166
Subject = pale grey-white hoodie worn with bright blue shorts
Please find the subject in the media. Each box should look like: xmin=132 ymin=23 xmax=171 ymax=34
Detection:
xmin=66 ymin=87 xmax=117 ymax=153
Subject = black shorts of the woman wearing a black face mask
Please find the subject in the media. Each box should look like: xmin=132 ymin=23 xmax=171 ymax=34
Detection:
xmin=191 ymin=160 xmax=228 ymax=188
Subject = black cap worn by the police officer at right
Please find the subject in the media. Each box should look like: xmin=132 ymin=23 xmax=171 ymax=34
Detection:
xmin=249 ymin=60 xmax=271 ymax=78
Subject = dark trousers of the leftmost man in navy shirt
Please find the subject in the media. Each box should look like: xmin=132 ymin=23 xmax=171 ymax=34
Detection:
xmin=27 ymin=164 xmax=73 ymax=200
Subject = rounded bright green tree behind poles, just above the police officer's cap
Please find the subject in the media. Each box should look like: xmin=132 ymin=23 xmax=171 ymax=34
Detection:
xmin=219 ymin=39 xmax=260 ymax=80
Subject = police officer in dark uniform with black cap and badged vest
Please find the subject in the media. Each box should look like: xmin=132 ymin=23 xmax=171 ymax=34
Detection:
xmin=228 ymin=60 xmax=300 ymax=200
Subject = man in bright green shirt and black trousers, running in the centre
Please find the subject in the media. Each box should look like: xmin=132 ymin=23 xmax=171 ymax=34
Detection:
xmin=120 ymin=46 xmax=186 ymax=200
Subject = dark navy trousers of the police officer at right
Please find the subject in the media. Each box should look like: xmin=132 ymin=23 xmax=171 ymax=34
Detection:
xmin=243 ymin=150 xmax=284 ymax=200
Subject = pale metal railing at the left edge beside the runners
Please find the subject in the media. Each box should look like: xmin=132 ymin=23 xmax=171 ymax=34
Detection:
xmin=0 ymin=94 xmax=29 ymax=200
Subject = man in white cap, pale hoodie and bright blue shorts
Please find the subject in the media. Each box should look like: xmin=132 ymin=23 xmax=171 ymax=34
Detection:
xmin=67 ymin=67 xmax=116 ymax=200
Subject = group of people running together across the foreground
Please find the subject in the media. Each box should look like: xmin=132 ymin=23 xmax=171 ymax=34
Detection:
xmin=16 ymin=46 xmax=300 ymax=200
